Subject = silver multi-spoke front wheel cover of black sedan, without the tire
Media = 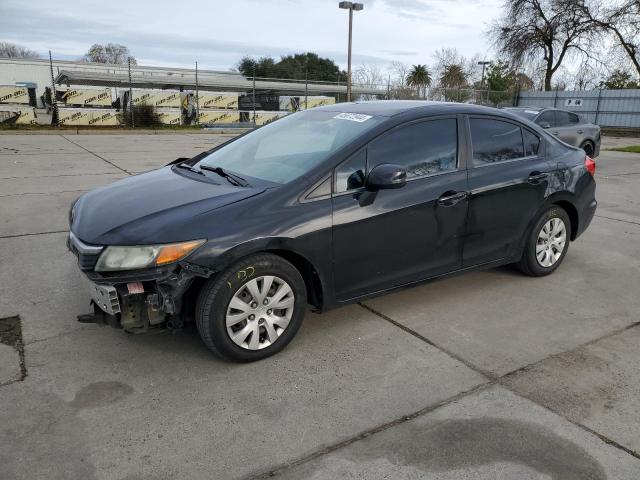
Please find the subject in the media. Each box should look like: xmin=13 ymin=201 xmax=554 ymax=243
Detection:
xmin=226 ymin=275 xmax=295 ymax=350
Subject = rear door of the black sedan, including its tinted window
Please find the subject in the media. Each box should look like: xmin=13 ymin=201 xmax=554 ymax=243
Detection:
xmin=463 ymin=116 xmax=555 ymax=267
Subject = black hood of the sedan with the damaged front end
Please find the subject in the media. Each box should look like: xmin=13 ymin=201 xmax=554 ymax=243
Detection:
xmin=71 ymin=167 xmax=265 ymax=245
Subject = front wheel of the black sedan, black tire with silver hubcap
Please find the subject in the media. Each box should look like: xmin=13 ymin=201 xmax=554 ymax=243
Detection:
xmin=195 ymin=253 xmax=307 ymax=362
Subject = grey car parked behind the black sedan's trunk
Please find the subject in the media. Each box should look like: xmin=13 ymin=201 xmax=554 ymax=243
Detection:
xmin=505 ymin=107 xmax=601 ymax=158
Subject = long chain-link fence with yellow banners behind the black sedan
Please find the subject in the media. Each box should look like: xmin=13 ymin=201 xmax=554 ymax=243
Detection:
xmin=0 ymin=54 xmax=513 ymax=128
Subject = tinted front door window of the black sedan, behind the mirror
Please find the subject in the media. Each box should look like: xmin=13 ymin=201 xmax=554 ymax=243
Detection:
xmin=368 ymin=118 xmax=458 ymax=178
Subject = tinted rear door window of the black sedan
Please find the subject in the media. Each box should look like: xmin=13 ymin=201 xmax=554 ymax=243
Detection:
xmin=469 ymin=118 xmax=525 ymax=165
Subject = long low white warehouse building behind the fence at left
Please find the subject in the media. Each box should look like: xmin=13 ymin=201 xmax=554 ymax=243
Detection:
xmin=0 ymin=58 xmax=385 ymax=125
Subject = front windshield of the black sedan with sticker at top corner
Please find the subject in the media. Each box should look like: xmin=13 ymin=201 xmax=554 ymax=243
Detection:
xmin=196 ymin=111 xmax=383 ymax=183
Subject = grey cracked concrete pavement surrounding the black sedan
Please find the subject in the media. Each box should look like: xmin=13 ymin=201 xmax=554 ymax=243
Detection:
xmin=0 ymin=134 xmax=640 ymax=480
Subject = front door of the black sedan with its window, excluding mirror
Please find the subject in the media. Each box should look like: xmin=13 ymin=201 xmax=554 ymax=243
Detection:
xmin=333 ymin=116 xmax=467 ymax=300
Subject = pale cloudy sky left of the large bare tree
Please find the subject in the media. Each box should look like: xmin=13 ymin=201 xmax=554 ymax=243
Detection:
xmin=0 ymin=0 xmax=502 ymax=70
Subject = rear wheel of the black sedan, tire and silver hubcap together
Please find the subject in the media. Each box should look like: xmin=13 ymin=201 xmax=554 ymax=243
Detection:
xmin=516 ymin=206 xmax=571 ymax=277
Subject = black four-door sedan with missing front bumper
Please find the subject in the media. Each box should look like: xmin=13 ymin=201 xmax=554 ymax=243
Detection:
xmin=68 ymin=101 xmax=597 ymax=361
